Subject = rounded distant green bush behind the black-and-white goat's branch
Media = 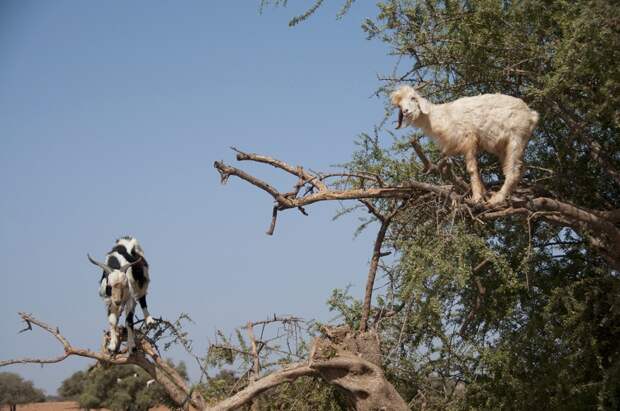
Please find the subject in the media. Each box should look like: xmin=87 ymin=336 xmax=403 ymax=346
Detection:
xmin=58 ymin=362 xmax=187 ymax=411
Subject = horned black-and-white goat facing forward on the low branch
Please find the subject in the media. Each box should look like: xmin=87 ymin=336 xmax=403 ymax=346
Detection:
xmin=88 ymin=237 xmax=155 ymax=354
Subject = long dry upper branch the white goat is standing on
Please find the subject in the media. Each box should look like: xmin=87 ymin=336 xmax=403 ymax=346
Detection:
xmin=214 ymin=150 xmax=620 ymax=270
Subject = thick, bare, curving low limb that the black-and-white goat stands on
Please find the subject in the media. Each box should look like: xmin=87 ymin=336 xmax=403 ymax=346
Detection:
xmin=0 ymin=313 xmax=407 ymax=411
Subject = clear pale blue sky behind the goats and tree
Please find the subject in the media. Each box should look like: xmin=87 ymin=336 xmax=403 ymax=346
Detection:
xmin=0 ymin=0 xmax=393 ymax=394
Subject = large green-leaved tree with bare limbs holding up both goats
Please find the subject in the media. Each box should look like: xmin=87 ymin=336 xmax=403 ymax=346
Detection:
xmin=5 ymin=0 xmax=620 ymax=410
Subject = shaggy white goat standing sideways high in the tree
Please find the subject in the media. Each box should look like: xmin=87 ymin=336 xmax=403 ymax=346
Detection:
xmin=390 ymin=86 xmax=538 ymax=205
